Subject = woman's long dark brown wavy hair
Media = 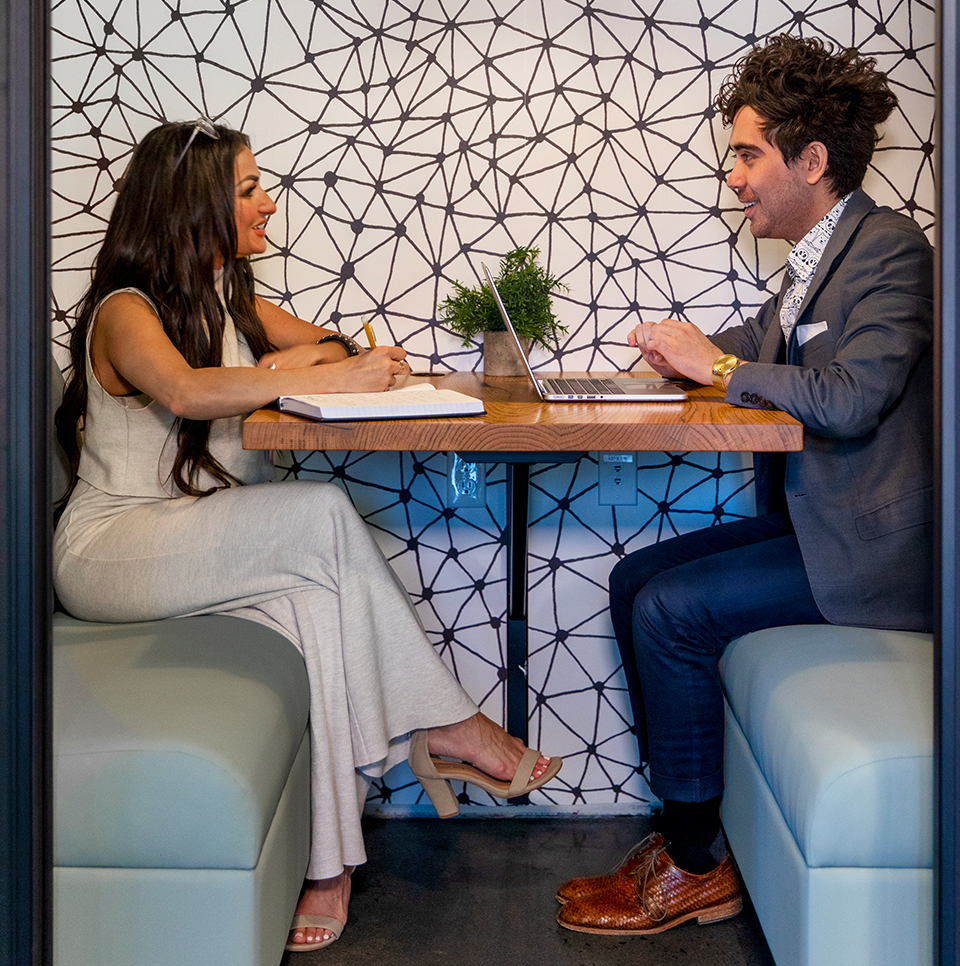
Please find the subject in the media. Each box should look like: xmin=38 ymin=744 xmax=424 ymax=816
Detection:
xmin=56 ymin=124 xmax=274 ymax=502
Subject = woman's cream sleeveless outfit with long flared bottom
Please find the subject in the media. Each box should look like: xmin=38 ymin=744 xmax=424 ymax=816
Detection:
xmin=54 ymin=289 xmax=477 ymax=879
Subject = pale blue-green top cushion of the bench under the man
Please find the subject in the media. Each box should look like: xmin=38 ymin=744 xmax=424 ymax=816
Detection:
xmin=721 ymin=625 xmax=934 ymax=869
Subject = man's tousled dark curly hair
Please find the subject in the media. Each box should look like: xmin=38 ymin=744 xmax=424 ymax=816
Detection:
xmin=715 ymin=34 xmax=897 ymax=197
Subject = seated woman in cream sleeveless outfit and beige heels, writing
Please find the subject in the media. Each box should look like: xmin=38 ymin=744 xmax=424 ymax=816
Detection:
xmin=54 ymin=119 xmax=560 ymax=950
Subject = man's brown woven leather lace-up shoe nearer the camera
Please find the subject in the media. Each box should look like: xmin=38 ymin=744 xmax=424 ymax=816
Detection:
xmin=557 ymin=846 xmax=743 ymax=936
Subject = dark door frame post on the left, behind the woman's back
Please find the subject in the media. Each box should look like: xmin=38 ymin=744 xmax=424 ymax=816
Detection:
xmin=0 ymin=0 xmax=53 ymax=966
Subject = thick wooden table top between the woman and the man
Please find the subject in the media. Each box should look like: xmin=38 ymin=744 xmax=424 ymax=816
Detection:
xmin=243 ymin=372 xmax=803 ymax=453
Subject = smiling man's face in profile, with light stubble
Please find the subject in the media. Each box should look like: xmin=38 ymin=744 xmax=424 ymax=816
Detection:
xmin=727 ymin=107 xmax=820 ymax=242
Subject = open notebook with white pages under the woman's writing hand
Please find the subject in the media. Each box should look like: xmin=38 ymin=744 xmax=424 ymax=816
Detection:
xmin=277 ymin=383 xmax=486 ymax=422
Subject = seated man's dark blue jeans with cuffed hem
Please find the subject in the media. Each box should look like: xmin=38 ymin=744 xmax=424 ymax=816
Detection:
xmin=610 ymin=514 xmax=827 ymax=802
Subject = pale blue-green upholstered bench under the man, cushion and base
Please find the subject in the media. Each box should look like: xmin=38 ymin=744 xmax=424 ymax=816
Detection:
xmin=721 ymin=625 xmax=934 ymax=966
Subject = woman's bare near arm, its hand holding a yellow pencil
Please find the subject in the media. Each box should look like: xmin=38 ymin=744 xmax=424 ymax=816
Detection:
xmin=91 ymin=292 xmax=406 ymax=419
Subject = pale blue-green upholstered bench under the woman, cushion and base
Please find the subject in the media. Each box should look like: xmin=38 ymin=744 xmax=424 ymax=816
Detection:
xmin=53 ymin=614 xmax=310 ymax=966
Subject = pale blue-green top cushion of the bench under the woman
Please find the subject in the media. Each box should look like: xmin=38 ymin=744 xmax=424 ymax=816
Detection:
xmin=53 ymin=614 xmax=309 ymax=869
